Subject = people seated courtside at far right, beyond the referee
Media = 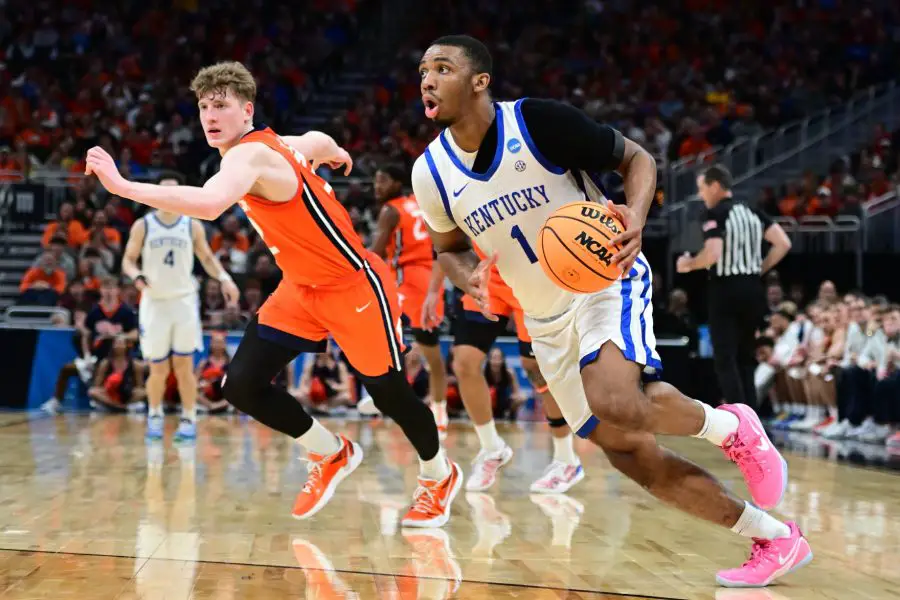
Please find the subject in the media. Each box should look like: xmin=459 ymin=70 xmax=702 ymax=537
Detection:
xmin=756 ymin=281 xmax=900 ymax=450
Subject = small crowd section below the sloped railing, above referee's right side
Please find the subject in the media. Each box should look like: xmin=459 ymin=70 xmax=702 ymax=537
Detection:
xmin=760 ymin=125 xmax=900 ymax=218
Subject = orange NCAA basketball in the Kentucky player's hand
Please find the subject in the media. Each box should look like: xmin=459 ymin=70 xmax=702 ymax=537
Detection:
xmin=537 ymin=202 xmax=625 ymax=294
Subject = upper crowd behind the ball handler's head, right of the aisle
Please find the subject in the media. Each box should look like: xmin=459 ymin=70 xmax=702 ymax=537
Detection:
xmin=331 ymin=0 xmax=900 ymax=176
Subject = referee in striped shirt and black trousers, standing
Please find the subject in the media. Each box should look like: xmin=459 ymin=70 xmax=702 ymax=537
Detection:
xmin=676 ymin=165 xmax=791 ymax=408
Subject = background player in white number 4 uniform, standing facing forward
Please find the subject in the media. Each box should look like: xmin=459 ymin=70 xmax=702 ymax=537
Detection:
xmin=122 ymin=177 xmax=240 ymax=439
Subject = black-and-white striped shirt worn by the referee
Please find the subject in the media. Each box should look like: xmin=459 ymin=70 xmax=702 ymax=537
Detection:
xmin=703 ymin=198 xmax=772 ymax=279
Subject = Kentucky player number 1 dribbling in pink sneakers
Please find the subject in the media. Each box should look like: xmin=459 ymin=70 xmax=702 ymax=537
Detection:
xmin=412 ymin=36 xmax=812 ymax=587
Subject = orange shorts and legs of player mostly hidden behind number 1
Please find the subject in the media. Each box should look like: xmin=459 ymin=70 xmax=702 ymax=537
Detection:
xmin=453 ymin=246 xmax=584 ymax=494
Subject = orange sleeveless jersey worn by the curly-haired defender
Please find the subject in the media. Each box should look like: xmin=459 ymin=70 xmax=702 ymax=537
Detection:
xmin=239 ymin=128 xmax=367 ymax=285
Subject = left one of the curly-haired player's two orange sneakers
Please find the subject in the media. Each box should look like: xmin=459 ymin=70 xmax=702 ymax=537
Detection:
xmin=291 ymin=435 xmax=363 ymax=519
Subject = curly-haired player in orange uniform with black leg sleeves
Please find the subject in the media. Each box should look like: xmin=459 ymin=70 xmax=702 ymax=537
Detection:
xmin=86 ymin=62 xmax=462 ymax=527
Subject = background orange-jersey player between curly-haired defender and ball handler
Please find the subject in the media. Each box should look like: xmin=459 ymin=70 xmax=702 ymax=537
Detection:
xmin=369 ymin=165 xmax=447 ymax=434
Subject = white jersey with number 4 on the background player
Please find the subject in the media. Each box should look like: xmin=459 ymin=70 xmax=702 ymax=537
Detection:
xmin=141 ymin=212 xmax=197 ymax=299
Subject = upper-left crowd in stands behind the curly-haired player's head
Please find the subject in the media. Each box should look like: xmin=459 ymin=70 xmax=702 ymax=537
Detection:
xmin=0 ymin=0 xmax=377 ymax=181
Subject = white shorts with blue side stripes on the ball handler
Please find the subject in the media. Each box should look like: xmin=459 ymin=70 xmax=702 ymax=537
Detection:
xmin=525 ymin=255 xmax=662 ymax=437
